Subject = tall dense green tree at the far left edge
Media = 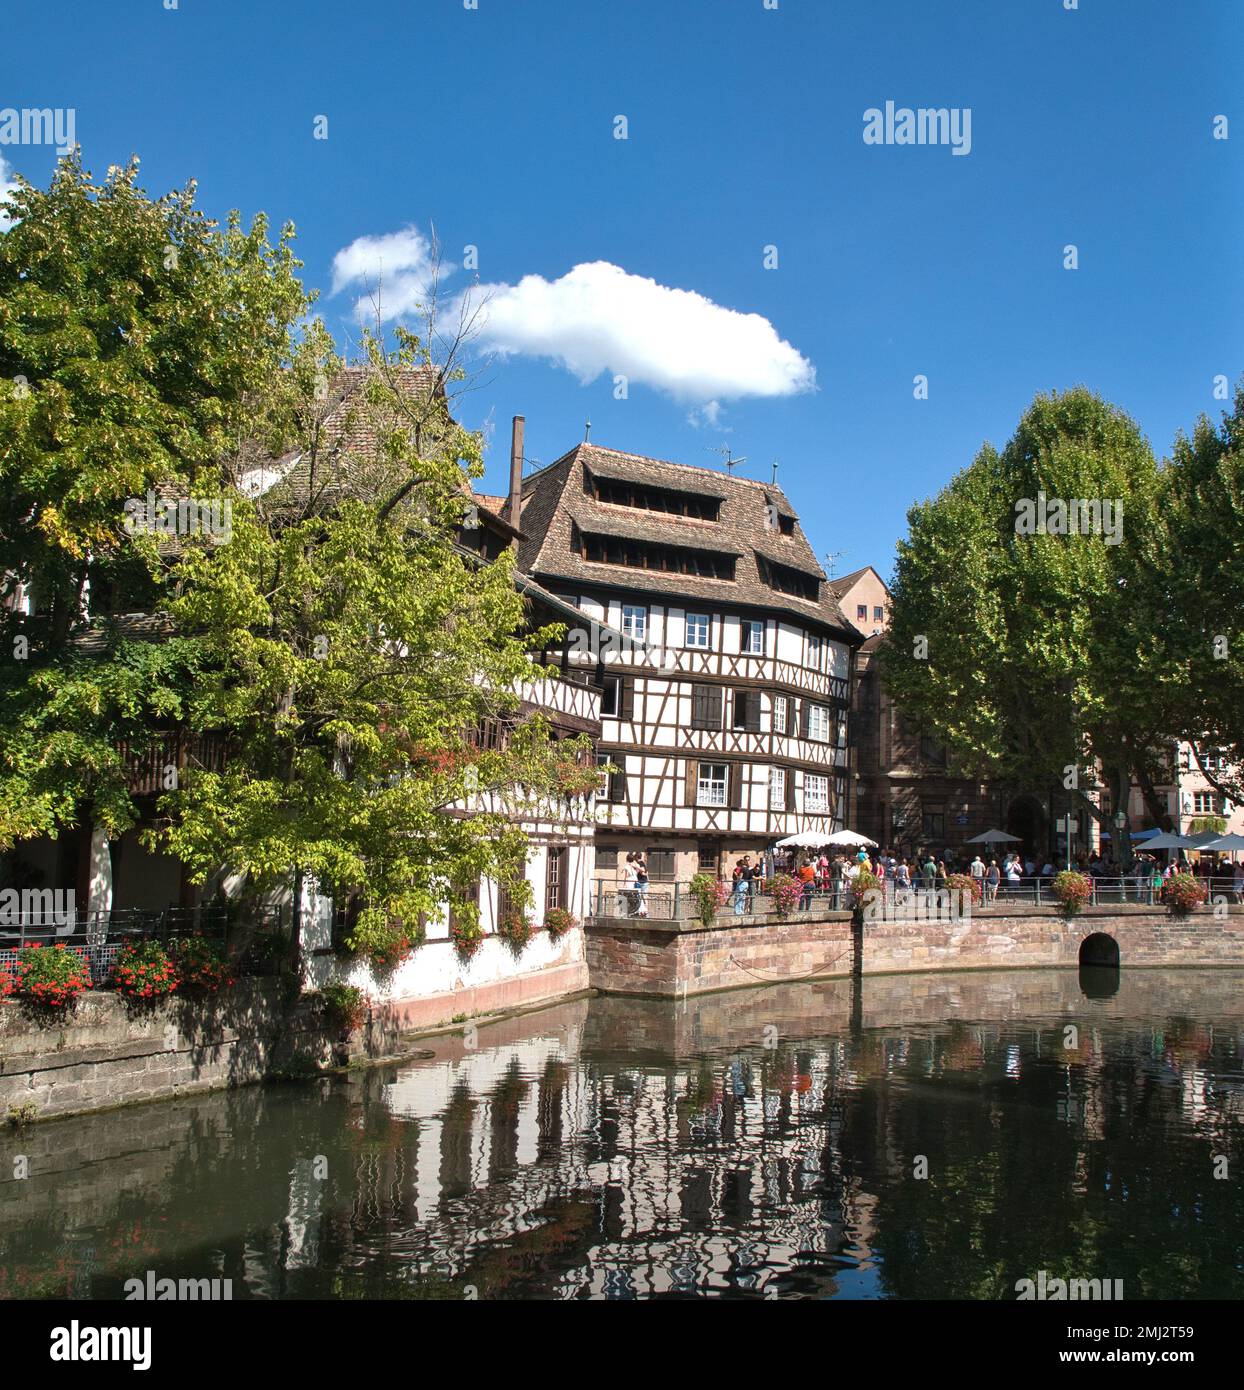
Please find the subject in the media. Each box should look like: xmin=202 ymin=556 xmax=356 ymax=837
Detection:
xmin=0 ymin=158 xmax=306 ymax=848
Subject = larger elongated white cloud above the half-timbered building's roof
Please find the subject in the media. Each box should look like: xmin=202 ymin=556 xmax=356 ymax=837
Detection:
xmin=480 ymin=261 xmax=816 ymax=405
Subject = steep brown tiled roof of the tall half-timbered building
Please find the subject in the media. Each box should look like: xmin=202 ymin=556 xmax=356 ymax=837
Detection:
xmin=518 ymin=443 xmax=855 ymax=637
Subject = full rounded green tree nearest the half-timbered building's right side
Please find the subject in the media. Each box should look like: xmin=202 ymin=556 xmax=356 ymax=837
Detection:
xmin=881 ymin=388 xmax=1183 ymax=855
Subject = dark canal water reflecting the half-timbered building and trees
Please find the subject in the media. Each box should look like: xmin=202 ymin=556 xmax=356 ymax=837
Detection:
xmin=0 ymin=970 xmax=1244 ymax=1300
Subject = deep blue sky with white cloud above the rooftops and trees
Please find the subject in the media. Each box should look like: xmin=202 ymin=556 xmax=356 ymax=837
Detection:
xmin=0 ymin=0 xmax=1244 ymax=574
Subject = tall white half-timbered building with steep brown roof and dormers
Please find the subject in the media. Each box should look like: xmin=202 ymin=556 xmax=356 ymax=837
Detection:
xmin=518 ymin=443 xmax=860 ymax=881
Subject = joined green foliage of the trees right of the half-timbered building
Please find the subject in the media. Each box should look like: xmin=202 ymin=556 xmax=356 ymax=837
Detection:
xmin=881 ymin=388 xmax=1244 ymax=850
